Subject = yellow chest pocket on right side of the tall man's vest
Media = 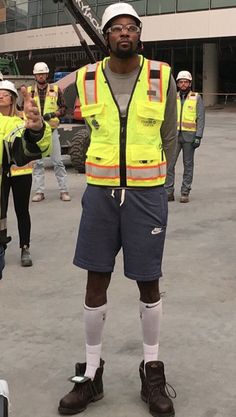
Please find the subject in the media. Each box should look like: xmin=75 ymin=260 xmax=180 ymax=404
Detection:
xmin=136 ymin=101 xmax=165 ymax=137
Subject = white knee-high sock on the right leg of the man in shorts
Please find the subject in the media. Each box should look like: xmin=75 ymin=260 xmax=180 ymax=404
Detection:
xmin=140 ymin=299 xmax=162 ymax=364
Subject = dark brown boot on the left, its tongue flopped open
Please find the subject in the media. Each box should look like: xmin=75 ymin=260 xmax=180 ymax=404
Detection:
xmin=58 ymin=359 xmax=105 ymax=415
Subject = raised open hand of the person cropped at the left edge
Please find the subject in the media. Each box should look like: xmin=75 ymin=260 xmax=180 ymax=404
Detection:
xmin=21 ymin=87 xmax=43 ymax=131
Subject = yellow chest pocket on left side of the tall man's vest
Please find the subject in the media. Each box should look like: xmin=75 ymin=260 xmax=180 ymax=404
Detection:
xmin=81 ymin=103 xmax=109 ymax=137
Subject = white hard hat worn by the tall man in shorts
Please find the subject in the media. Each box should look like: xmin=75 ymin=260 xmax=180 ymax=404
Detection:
xmin=101 ymin=3 xmax=142 ymax=31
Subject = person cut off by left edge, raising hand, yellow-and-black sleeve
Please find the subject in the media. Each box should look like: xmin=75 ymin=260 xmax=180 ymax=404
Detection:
xmin=0 ymin=81 xmax=52 ymax=278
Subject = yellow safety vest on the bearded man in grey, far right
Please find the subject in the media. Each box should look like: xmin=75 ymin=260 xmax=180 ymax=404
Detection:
xmin=177 ymin=91 xmax=199 ymax=132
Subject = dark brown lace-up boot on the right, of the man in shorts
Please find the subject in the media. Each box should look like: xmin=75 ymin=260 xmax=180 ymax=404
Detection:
xmin=139 ymin=361 xmax=176 ymax=417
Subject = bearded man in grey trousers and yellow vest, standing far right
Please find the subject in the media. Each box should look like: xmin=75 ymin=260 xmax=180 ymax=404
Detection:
xmin=166 ymin=71 xmax=205 ymax=203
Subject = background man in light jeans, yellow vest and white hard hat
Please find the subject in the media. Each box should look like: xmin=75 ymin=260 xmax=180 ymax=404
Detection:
xmin=28 ymin=62 xmax=70 ymax=202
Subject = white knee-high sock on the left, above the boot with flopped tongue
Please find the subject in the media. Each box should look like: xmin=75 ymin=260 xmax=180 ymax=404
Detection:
xmin=84 ymin=304 xmax=107 ymax=379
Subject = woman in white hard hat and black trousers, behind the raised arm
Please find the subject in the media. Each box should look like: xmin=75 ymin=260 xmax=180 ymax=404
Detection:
xmin=0 ymin=80 xmax=32 ymax=266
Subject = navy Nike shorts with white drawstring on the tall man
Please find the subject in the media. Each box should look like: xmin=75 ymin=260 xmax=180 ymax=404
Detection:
xmin=74 ymin=185 xmax=168 ymax=281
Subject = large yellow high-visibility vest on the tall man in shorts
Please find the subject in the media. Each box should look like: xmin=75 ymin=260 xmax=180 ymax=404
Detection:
xmin=77 ymin=56 xmax=170 ymax=187
